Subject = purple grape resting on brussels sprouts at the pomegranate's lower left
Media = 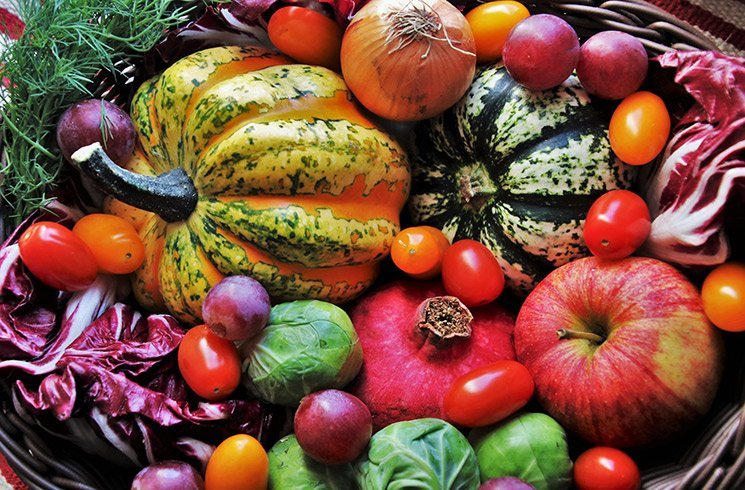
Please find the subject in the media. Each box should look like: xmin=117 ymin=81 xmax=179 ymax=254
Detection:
xmin=295 ymin=390 xmax=372 ymax=465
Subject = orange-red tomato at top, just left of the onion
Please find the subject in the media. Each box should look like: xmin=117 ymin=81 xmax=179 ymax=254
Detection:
xmin=267 ymin=6 xmax=344 ymax=71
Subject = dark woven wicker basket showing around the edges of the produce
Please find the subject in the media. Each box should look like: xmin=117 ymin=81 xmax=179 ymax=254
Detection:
xmin=0 ymin=0 xmax=745 ymax=490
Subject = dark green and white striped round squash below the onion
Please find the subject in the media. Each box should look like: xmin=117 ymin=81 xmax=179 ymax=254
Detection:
xmin=409 ymin=65 xmax=634 ymax=294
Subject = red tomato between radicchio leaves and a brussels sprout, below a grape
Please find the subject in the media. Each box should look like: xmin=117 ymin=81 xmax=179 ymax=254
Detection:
xmin=178 ymin=325 xmax=241 ymax=401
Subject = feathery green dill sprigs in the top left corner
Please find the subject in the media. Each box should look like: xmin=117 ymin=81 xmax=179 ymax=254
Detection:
xmin=0 ymin=0 xmax=195 ymax=224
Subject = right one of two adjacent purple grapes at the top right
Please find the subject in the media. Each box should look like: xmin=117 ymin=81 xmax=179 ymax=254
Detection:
xmin=577 ymin=31 xmax=649 ymax=100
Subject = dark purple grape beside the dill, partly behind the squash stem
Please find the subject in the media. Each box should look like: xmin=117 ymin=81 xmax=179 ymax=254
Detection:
xmin=57 ymin=99 xmax=135 ymax=165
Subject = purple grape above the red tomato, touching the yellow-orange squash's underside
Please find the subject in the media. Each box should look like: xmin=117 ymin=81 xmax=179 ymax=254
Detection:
xmin=202 ymin=276 xmax=272 ymax=340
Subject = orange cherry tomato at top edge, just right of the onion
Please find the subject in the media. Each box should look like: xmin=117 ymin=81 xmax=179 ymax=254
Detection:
xmin=466 ymin=0 xmax=530 ymax=63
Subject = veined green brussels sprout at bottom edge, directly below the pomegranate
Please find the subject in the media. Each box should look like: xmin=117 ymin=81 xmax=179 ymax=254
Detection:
xmin=357 ymin=418 xmax=480 ymax=490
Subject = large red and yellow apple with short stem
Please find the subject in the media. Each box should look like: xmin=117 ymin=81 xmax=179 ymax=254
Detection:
xmin=515 ymin=257 xmax=723 ymax=447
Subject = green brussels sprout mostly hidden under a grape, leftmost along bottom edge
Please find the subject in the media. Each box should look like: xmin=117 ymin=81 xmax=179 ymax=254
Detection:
xmin=268 ymin=434 xmax=358 ymax=490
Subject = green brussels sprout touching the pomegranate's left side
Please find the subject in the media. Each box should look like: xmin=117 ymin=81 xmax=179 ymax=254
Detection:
xmin=241 ymin=300 xmax=362 ymax=407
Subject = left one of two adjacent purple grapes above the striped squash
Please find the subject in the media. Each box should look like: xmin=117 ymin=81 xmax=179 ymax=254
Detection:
xmin=502 ymin=14 xmax=579 ymax=90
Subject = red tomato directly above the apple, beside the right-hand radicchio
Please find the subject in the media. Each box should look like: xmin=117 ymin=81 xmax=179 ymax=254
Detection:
xmin=583 ymin=189 xmax=652 ymax=260
